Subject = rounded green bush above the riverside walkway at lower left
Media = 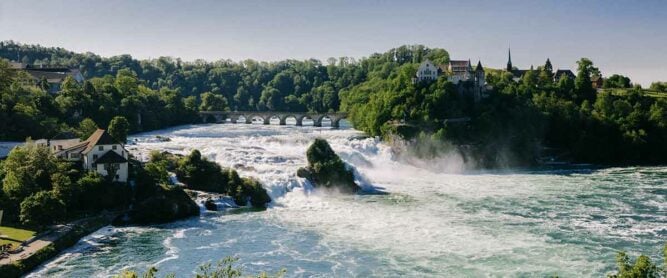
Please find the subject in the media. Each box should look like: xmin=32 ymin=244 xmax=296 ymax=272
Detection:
xmin=19 ymin=191 xmax=65 ymax=227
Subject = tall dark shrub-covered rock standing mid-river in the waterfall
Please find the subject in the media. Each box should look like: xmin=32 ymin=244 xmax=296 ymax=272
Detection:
xmin=296 ymin=138 xmax=361 ymax=193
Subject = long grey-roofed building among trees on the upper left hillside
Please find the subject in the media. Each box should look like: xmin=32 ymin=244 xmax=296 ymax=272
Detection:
xmin=10 ymin=62 xmax=84 ymax=94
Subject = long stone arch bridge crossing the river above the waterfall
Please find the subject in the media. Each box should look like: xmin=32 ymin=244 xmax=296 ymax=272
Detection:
xmin=199 ymin=111 xmax=347 ymax=128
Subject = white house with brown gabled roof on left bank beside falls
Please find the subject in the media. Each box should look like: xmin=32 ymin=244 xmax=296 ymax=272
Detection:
xmin=55 ymin=129 xmax=129 ymax=182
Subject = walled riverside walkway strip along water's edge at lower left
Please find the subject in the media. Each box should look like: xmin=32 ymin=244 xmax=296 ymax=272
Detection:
xmin=0 ymin=213 xmax=117 ymax=278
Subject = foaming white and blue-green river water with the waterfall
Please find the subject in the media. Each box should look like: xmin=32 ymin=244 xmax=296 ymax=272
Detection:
xmin=31 ymin=120 xmax=667 ymax=277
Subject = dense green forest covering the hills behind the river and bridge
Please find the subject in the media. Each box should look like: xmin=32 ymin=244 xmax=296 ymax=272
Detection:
xmin=0 ymin=41 xmax=667 ymax=167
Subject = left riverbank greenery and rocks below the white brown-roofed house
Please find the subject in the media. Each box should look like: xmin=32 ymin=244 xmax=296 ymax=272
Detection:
xmin=0 ymin=139 xmax=271 ymax=277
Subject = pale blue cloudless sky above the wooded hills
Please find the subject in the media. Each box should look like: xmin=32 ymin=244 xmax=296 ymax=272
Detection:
xmin=0 ymin=0 xmax=667 ymax=86
